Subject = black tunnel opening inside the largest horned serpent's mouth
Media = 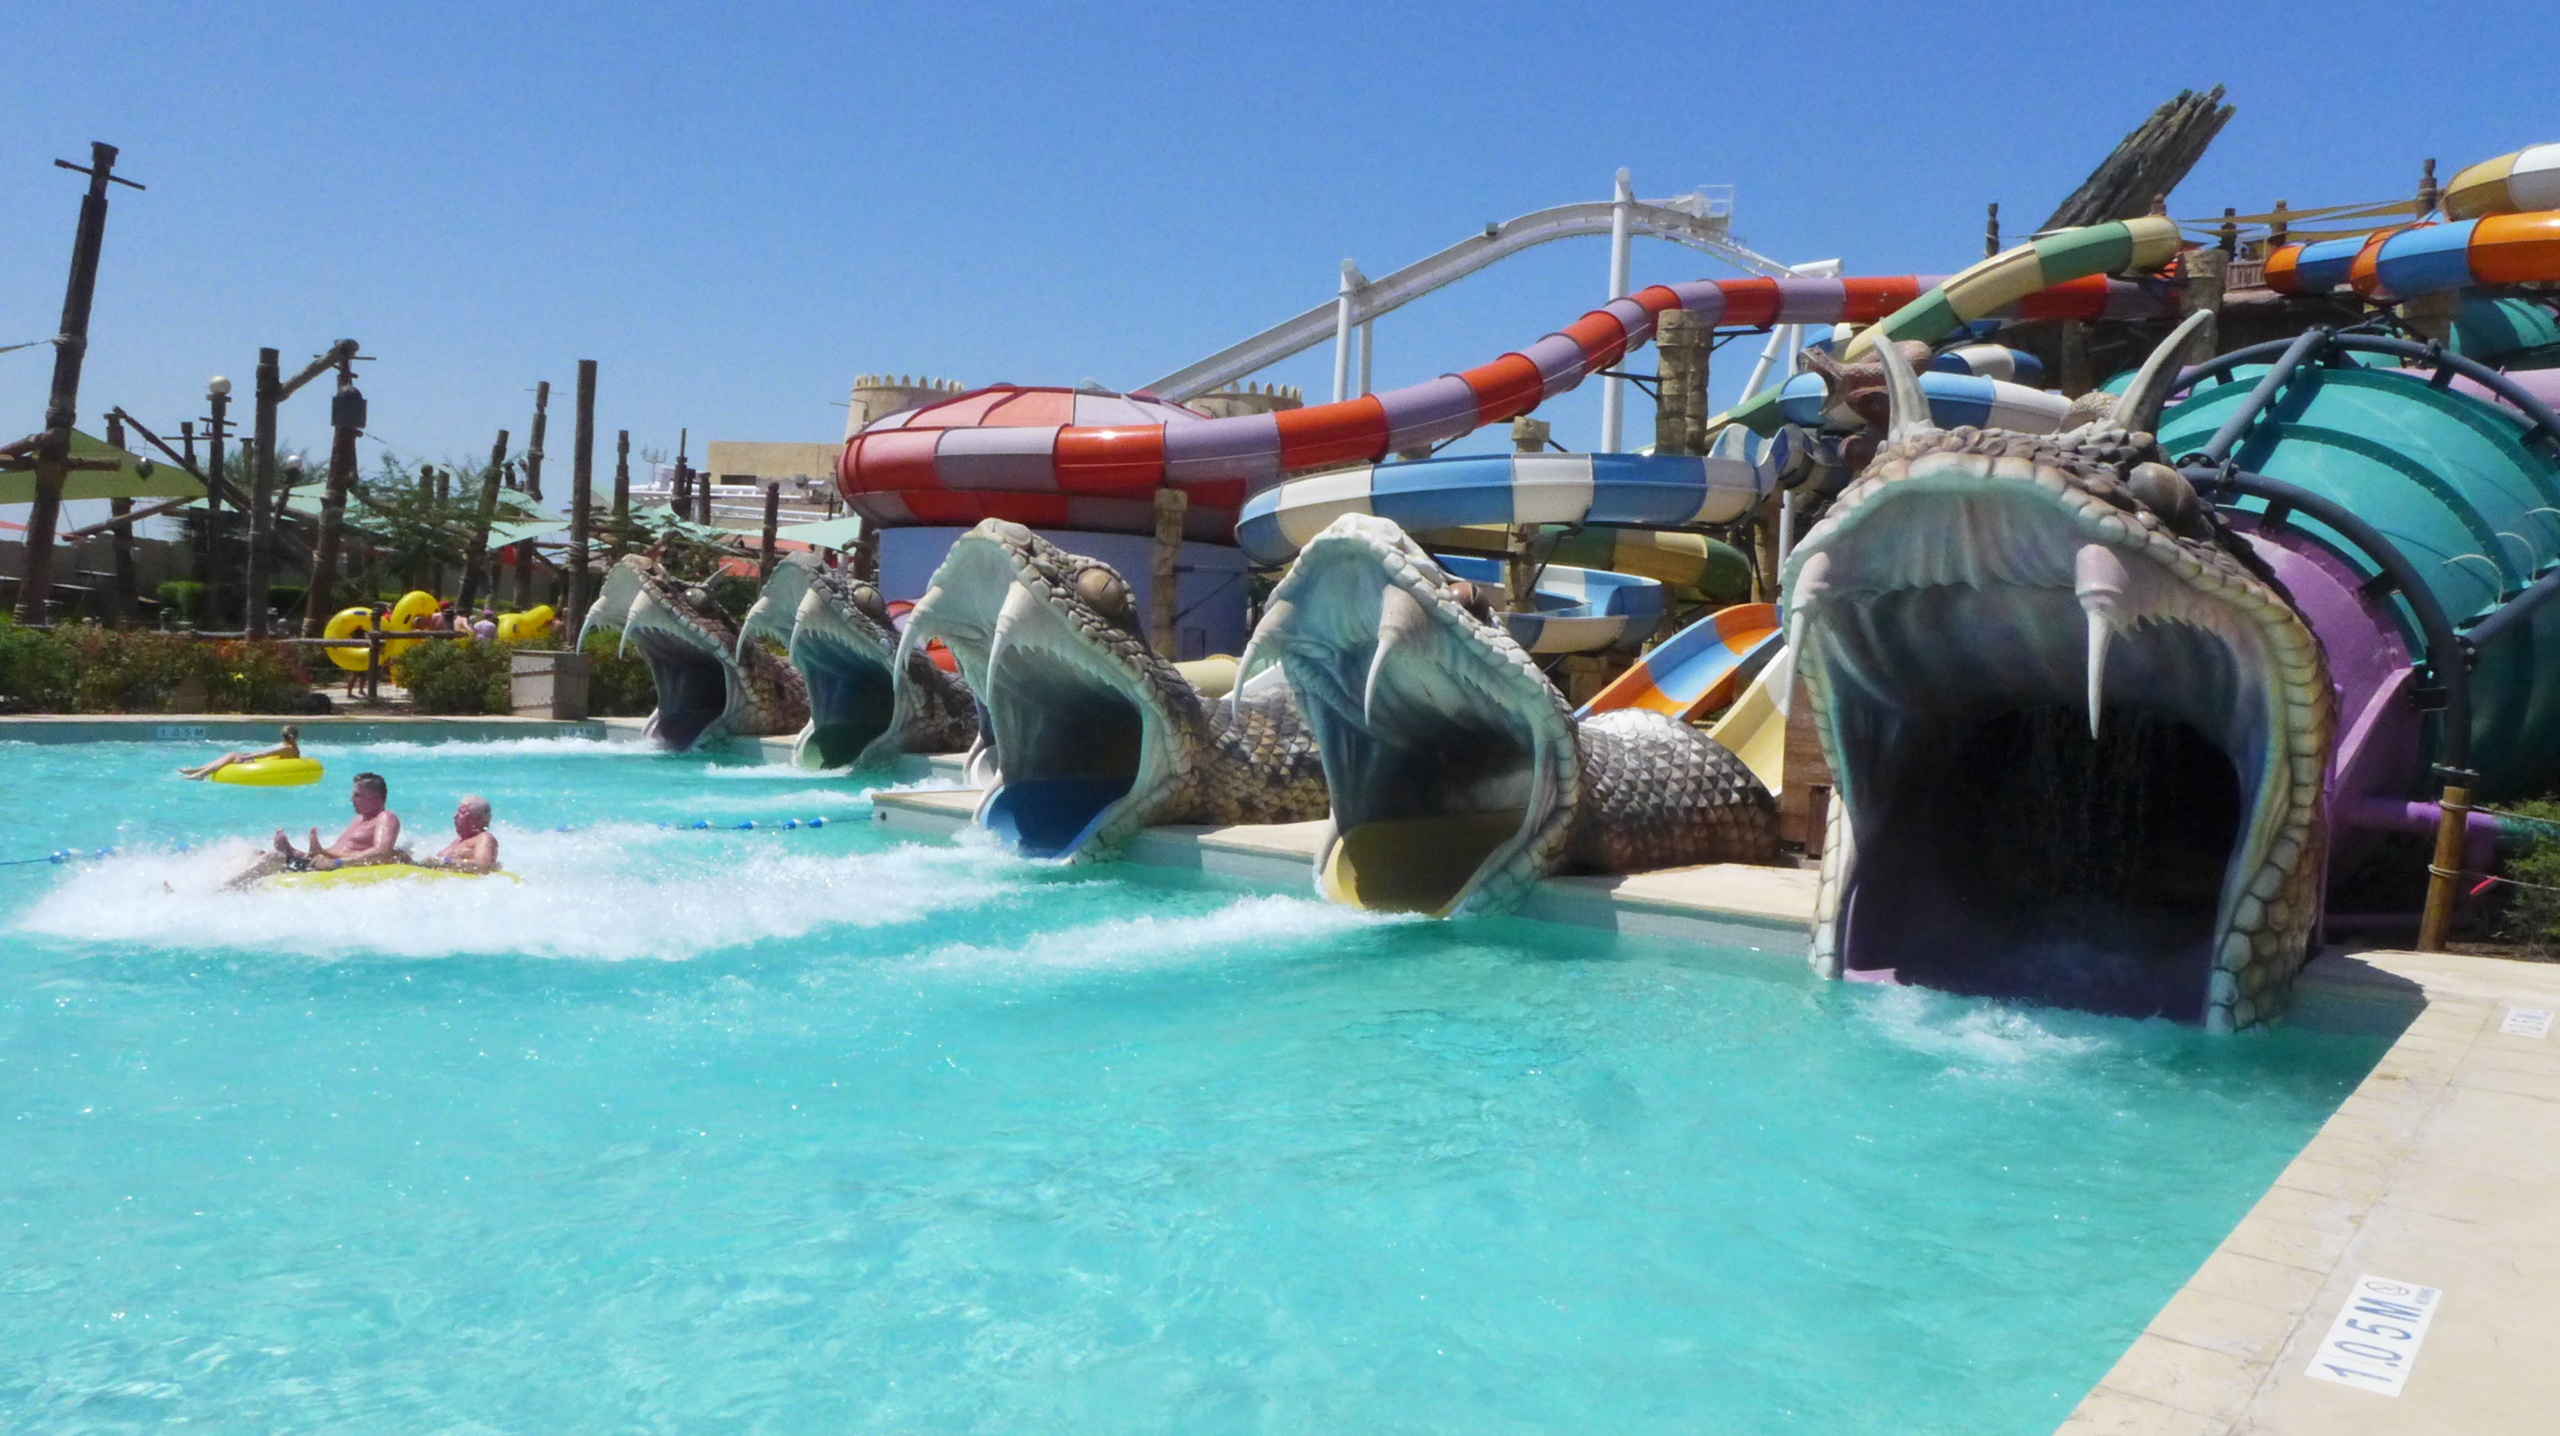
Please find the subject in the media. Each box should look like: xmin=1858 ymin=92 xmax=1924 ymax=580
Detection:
xmin=1843 ymin=704 xmax=2248 ymax=1021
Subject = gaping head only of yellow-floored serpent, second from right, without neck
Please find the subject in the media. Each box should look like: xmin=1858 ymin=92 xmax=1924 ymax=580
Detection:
xmin=1242 ymin=520 xmax=1577 ymax=914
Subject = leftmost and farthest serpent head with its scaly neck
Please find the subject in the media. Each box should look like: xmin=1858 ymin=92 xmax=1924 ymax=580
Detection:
xmin=586 ymin=553 xmax=809 ymax=750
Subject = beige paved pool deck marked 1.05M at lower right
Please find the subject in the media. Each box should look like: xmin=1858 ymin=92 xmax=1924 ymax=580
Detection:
xmin=2056 ymin=952 xmax=2560 ymax=1436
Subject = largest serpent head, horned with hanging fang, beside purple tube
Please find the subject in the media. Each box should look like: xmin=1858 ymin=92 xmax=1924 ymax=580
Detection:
xmin=1784 ymin=323 xmax=2335 ymax=1032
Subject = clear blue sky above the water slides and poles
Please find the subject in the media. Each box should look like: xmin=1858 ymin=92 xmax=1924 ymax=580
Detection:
xmin=0 ymin=0 xmax=2560 ymax=474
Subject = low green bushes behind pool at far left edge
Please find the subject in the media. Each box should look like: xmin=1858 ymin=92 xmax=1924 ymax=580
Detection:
xmin=0 ymin=622 xmax=310 ymax=714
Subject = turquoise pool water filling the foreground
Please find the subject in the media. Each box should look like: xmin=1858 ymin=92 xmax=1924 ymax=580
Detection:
xmin=0 ymin=742 xmax=2383 ymax=1436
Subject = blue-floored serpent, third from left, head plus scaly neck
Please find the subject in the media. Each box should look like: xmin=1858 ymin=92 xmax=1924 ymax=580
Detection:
xmin=899 ymin=520 xmax=1326 ymax=863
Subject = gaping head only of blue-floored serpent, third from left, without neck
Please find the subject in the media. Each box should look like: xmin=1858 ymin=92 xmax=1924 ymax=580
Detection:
xmin=899 ymin=520 xmax=1198 ymax=860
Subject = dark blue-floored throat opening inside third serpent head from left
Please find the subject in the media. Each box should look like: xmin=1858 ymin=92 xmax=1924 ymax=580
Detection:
xmin=986 ymin=650 xmax=1147 ymax=858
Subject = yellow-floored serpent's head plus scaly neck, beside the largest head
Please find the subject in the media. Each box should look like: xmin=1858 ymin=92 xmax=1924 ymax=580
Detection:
xmin=1239 ymin=515 xmax=1777 ymax=914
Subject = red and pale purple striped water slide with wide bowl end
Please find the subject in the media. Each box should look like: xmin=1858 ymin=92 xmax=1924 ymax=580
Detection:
xmin=837 ymin=274 xmax=2163 ymax=543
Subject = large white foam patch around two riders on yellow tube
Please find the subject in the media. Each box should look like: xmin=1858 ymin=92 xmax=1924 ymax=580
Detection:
xmin=20 ymin=824 xmax=1021 ymax=962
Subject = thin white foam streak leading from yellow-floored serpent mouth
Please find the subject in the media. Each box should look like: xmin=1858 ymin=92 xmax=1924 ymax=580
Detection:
xmin=911 ymin=896 xmax=1416 ymax=973
